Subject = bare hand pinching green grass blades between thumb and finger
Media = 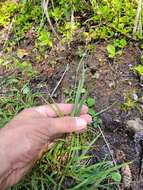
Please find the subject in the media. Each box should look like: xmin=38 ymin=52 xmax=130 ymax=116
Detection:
xmin=0 ymin=104 xmax=92 ymax=190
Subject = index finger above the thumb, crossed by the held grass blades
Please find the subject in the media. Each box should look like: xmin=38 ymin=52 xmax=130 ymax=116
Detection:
xmin=34 ymin=104 xmax=88 ymax=117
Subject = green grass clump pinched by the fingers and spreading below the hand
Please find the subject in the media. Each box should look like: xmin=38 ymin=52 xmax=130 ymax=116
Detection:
xmin=9 ymin=52 xmax=121 ymax=190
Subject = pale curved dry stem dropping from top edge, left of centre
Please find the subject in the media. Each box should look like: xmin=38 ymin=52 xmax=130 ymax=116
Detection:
xmin=42 ymin=0 xmax=61 ymax=41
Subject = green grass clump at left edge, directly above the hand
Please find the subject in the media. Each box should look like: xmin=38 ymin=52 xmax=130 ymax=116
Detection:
xmin=0 ymin=74 xmax=39 ymax=128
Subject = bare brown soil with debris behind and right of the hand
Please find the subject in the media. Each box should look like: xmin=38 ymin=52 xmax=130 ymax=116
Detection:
xmin=1 ymin=36 xmax=143 ymax=190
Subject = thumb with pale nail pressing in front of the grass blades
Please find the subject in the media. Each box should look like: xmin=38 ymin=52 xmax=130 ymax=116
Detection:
xmin=46 ymin=117 xmax=87 ymax=137
